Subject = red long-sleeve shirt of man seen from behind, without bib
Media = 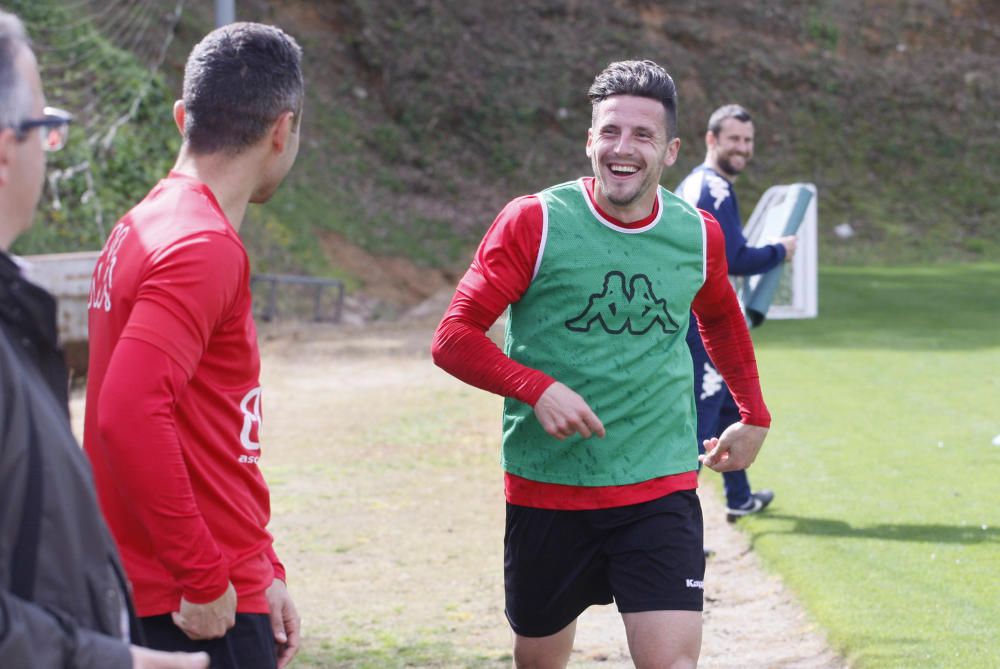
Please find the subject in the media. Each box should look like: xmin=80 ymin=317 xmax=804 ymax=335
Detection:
xmin=84 ymin=173 xmax=284 ymax=616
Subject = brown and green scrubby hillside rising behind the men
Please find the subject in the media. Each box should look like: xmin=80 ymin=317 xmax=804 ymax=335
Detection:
xmin=10 ymin=0 xmax=1000 ymax=282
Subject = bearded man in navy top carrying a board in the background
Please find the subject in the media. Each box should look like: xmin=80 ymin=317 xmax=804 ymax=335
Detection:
xmin=677 ymin=105 xmax=796 ymax=521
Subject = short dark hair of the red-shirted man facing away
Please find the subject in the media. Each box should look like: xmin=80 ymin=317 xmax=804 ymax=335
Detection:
xmin=184 ymin=23 xmax=304 ymax=154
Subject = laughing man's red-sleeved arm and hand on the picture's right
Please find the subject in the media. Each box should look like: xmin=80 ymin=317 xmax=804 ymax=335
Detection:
xmin=692 ymin=212 xmax=771 ymax=471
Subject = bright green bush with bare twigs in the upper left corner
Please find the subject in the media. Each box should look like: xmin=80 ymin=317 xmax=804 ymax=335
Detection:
xmin=11 ymin=0 xmax=180 ymax=253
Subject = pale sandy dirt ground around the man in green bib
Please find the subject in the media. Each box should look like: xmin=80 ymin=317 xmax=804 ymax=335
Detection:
xmin=73 ymin=322 xmax=846 ymax=669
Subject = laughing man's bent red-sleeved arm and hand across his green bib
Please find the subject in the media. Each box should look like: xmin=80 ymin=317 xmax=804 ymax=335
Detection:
xmin=431 ymin=196 xmax=604 ymax=439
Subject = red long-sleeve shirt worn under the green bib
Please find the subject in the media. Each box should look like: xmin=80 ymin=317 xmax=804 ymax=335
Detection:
xmin=431 ymin=178 xmax=771 ymax=509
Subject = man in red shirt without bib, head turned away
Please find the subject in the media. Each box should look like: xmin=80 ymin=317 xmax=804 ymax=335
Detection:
xmin=84 ymin=23 xmax=303 ymax=669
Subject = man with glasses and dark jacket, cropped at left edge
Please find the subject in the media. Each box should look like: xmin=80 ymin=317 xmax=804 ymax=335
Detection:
xmin=0 ymin=11 xmax=208 ymax=669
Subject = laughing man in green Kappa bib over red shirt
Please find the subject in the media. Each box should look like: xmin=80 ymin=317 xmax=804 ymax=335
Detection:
xmin=432 ymin=61 xmax=770 ymax=669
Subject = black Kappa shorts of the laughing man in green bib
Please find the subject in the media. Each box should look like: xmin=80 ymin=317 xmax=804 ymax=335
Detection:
xmin=504 ymin=490 xmax=705 ymax=637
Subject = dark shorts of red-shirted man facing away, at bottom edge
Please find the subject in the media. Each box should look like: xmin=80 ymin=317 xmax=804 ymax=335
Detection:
xmin=139 ymin=613 xmax=278 ymax=669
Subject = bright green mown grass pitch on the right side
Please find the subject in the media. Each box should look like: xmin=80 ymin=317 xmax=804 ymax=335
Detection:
xmin=742 ymin=264 xmax=1000 ymax=669
